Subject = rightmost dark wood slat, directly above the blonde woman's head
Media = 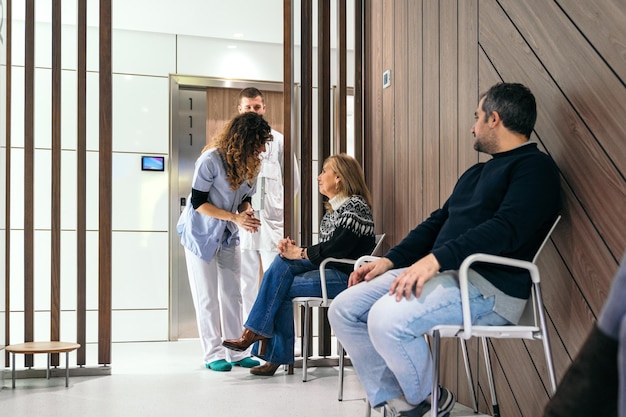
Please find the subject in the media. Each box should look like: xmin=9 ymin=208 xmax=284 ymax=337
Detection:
xmin=354 ymin=0 xmax=365 ymax=165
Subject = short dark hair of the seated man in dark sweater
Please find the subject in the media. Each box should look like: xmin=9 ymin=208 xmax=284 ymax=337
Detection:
xmin=481 ymin=83 xmax=537 ymax=138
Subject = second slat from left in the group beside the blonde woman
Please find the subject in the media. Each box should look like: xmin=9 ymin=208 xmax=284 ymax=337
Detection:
xmin=300 ymin=0 xmax=313 ymax=246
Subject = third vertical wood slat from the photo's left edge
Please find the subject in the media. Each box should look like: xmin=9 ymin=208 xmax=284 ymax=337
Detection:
xmin=50 ymin=1 xmax=62 ymax=366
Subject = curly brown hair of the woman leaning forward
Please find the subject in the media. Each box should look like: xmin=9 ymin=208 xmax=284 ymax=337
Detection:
xmin=202 ymin=112 xmax=272 ymax=190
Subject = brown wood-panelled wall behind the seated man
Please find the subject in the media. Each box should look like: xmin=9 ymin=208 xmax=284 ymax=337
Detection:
xmin=364 ymin=0 xmax=626 ymax=416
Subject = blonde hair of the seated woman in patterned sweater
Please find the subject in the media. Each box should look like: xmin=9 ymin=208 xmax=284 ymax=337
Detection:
xmin=324 ymin=153 xmax=372 ymax=210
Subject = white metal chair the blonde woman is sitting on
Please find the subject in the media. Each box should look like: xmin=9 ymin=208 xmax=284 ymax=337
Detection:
xmin=293 ymin=233 xmax=385 ymax=382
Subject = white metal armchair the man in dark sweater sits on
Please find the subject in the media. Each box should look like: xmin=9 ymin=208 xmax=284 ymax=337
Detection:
xmin=348 ymin=215 xmax=561 ymax=417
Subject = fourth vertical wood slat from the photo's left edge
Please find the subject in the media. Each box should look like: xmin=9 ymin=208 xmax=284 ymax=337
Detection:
xmin=76 ymin=0 xmax=87 ymax=365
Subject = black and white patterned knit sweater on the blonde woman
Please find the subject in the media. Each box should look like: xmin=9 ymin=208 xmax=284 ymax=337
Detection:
xmin=307 ymin=195 xmax=376 ymax=274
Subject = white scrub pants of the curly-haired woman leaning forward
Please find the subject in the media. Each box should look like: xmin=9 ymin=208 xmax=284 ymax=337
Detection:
xmin=185 ymin=246 xmax=250 ymax=364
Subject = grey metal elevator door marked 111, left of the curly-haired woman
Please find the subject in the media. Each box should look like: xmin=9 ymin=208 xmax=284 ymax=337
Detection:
xmin=172 ymin=89 xmax=207 ymax=339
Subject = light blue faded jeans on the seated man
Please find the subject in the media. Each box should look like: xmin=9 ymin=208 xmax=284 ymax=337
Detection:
xmin=328 ymin=269 xmax=508 ymax=407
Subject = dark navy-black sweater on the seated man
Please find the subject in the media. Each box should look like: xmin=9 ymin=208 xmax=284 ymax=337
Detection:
xmin=385 ymin=143 xmax=561 ymax=298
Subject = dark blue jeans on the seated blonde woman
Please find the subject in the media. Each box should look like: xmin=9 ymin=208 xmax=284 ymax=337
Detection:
xmin=244 ymin=256 xmax=348 ymax=365
